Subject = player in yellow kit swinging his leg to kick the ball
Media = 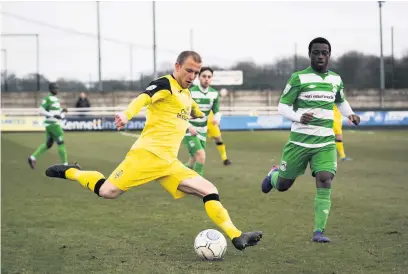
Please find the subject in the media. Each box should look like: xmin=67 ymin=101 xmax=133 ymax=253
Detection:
xmin=46 ymin=51 xmax=262 ymax=250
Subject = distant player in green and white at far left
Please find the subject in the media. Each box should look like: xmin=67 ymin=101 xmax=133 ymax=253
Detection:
xmin=28 ymin=83 xmax=68 ymax=169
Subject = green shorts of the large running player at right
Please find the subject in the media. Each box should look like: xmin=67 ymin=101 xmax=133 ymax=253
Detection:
xmin=279 ymin=142 xmax=337 ymax=179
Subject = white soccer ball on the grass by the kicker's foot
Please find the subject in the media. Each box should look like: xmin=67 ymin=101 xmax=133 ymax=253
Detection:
xmin=194 ymin=229 xmax=227 ymax=261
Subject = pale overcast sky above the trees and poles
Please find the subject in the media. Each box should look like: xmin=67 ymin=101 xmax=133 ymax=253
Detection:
xmin=1 ymin=1 xmax=408 ymax=81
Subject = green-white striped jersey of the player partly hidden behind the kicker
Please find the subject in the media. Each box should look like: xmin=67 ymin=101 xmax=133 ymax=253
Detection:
xmin=186 ymin=86 xmax=220 ymax=141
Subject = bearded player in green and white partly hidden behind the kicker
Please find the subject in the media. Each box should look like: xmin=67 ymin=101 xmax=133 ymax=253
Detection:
xmin=183 ymin=67 xmax=221 ymax=176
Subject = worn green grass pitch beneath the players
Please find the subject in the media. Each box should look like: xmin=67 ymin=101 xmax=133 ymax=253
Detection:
xmin=1 ymin=130 xmax=408 ymax=274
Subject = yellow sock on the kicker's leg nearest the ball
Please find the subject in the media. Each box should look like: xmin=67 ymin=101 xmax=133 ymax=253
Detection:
xmin=204 ymin=200 xmax=242 ymax=240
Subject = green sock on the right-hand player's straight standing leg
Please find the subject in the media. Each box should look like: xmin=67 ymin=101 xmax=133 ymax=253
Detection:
xmin=313 ymin=188 xmax=331 ymax=232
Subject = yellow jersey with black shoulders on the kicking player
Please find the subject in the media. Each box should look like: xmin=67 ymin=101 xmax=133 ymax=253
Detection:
xmin=131 ymin=75 xmax=204 ymax=162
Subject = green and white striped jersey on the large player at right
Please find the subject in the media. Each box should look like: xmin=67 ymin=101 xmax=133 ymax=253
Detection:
xmin=280 ymin=67 xmax=345 ymax=148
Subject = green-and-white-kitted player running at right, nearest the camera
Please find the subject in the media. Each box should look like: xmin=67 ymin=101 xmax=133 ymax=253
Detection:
xmin=262 ymin=37 xmax=360 ymax=242
